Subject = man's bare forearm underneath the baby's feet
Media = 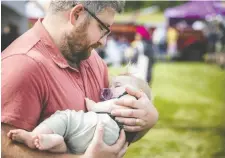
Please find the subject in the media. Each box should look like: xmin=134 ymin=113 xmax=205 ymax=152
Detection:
xmin=1 ymin=123 xmax=81 ymax=158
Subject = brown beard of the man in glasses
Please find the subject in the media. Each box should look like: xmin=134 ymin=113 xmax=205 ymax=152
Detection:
xmin=61 ymin=19 xmax=98 ymax=66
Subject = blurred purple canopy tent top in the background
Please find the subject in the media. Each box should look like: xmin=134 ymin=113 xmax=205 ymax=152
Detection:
xmin=164 ymin=1 xmax=225 ymax=24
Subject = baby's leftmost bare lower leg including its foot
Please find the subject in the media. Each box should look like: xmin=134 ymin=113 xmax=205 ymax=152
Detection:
xmin=7 ymin=124 xmax=53 ymax=149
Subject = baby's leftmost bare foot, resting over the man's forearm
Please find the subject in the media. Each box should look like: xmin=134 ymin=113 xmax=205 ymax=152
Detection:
xmin=7 ymin=129 xmax=35 ymax=149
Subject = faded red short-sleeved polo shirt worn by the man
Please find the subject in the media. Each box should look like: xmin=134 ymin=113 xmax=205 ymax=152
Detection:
xmin=1 ymin=21 xmax=108 ymax=130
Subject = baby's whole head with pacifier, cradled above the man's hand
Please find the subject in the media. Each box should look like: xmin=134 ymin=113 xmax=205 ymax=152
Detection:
xmin=101 ymin=75 xmax=152 ymax=100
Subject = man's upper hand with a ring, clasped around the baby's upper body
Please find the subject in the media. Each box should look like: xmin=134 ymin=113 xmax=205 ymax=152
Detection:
xmin=111 ymin=87 xmax=158 ymax=132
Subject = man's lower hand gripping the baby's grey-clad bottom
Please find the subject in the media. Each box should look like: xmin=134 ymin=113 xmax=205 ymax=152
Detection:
xmin=82 ymin=123 xmax=128 ymax=158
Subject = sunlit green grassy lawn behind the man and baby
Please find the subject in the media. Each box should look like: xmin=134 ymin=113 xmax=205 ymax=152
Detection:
xmin=110 ymin=63 xmax=225 ymax=158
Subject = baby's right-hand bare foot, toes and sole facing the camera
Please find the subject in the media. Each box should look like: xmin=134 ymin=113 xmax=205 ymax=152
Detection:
xmin=34 ymin=134 xmax=64 ymax=150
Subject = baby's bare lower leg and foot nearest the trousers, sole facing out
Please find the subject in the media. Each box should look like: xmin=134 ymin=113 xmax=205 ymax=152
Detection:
xmin=34 ymin=134 xmax=67 ymax=153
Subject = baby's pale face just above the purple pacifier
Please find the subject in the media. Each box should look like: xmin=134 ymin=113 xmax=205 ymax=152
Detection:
xmin=110 ymin=76 xmax=136 ymax=98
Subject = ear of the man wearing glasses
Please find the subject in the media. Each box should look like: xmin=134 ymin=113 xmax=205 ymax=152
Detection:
xmin=70 ymin=4 xmax=84 ymax=25
